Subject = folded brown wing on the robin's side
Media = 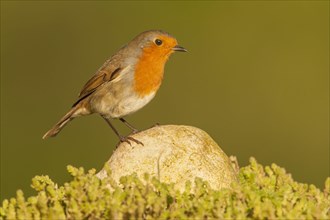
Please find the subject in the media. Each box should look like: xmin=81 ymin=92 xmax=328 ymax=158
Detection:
xmin=72 ymin=60 xmax=121 ymax=107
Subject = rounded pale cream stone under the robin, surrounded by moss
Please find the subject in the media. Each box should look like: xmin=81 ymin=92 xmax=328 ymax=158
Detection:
xmin=97 ymin=125 xmax=237 ymax=191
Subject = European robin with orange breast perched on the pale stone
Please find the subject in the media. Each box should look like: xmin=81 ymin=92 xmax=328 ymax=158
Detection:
xmin=43 ymin=30 xmax=187 ymax=145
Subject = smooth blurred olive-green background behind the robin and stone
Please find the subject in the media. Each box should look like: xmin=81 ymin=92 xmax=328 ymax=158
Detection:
xmin=1 ymin=1 xmax=329 ymax=200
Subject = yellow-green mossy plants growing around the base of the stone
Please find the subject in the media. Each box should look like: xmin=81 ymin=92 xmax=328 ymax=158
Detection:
xmin=0 ymin=158 xmax=330 ymax=219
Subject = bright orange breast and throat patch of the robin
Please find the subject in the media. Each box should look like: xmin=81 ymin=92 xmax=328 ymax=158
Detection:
xmin=134 ymin=46 xmax=169 ymax=97
